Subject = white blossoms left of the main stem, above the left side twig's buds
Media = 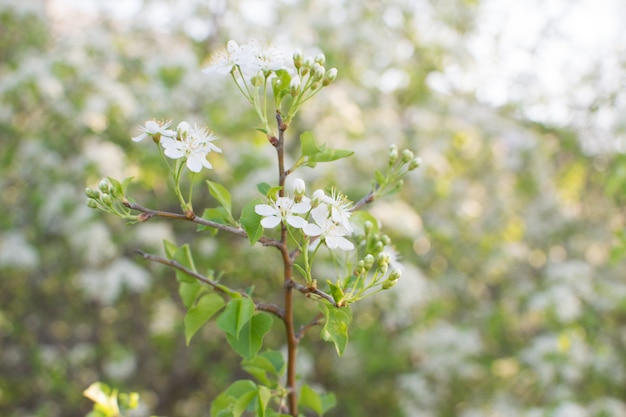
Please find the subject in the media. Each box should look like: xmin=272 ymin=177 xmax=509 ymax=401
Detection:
xmin=132 ymin=120 xmax=222 ymax=172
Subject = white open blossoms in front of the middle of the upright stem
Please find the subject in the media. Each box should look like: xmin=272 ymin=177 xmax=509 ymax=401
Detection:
xmin=254 ymin=178 xmax=354 ymax=250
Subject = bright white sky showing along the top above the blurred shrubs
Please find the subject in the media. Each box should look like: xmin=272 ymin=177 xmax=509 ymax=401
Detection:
xmin=41 ymin=0 xmax=626 ymax=153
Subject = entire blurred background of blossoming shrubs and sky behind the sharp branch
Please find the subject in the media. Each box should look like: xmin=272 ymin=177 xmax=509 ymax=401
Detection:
xmin=0 ymin=0 xmax=626 ymax=417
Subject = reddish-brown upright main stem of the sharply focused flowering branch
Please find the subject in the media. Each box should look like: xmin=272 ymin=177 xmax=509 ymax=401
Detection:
xmin=272 ymin=111 xmax=298 ymax=417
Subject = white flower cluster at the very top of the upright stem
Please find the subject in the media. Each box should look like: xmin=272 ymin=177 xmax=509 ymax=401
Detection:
xmin=203 ymin=40 xmax=286 ymax=79
